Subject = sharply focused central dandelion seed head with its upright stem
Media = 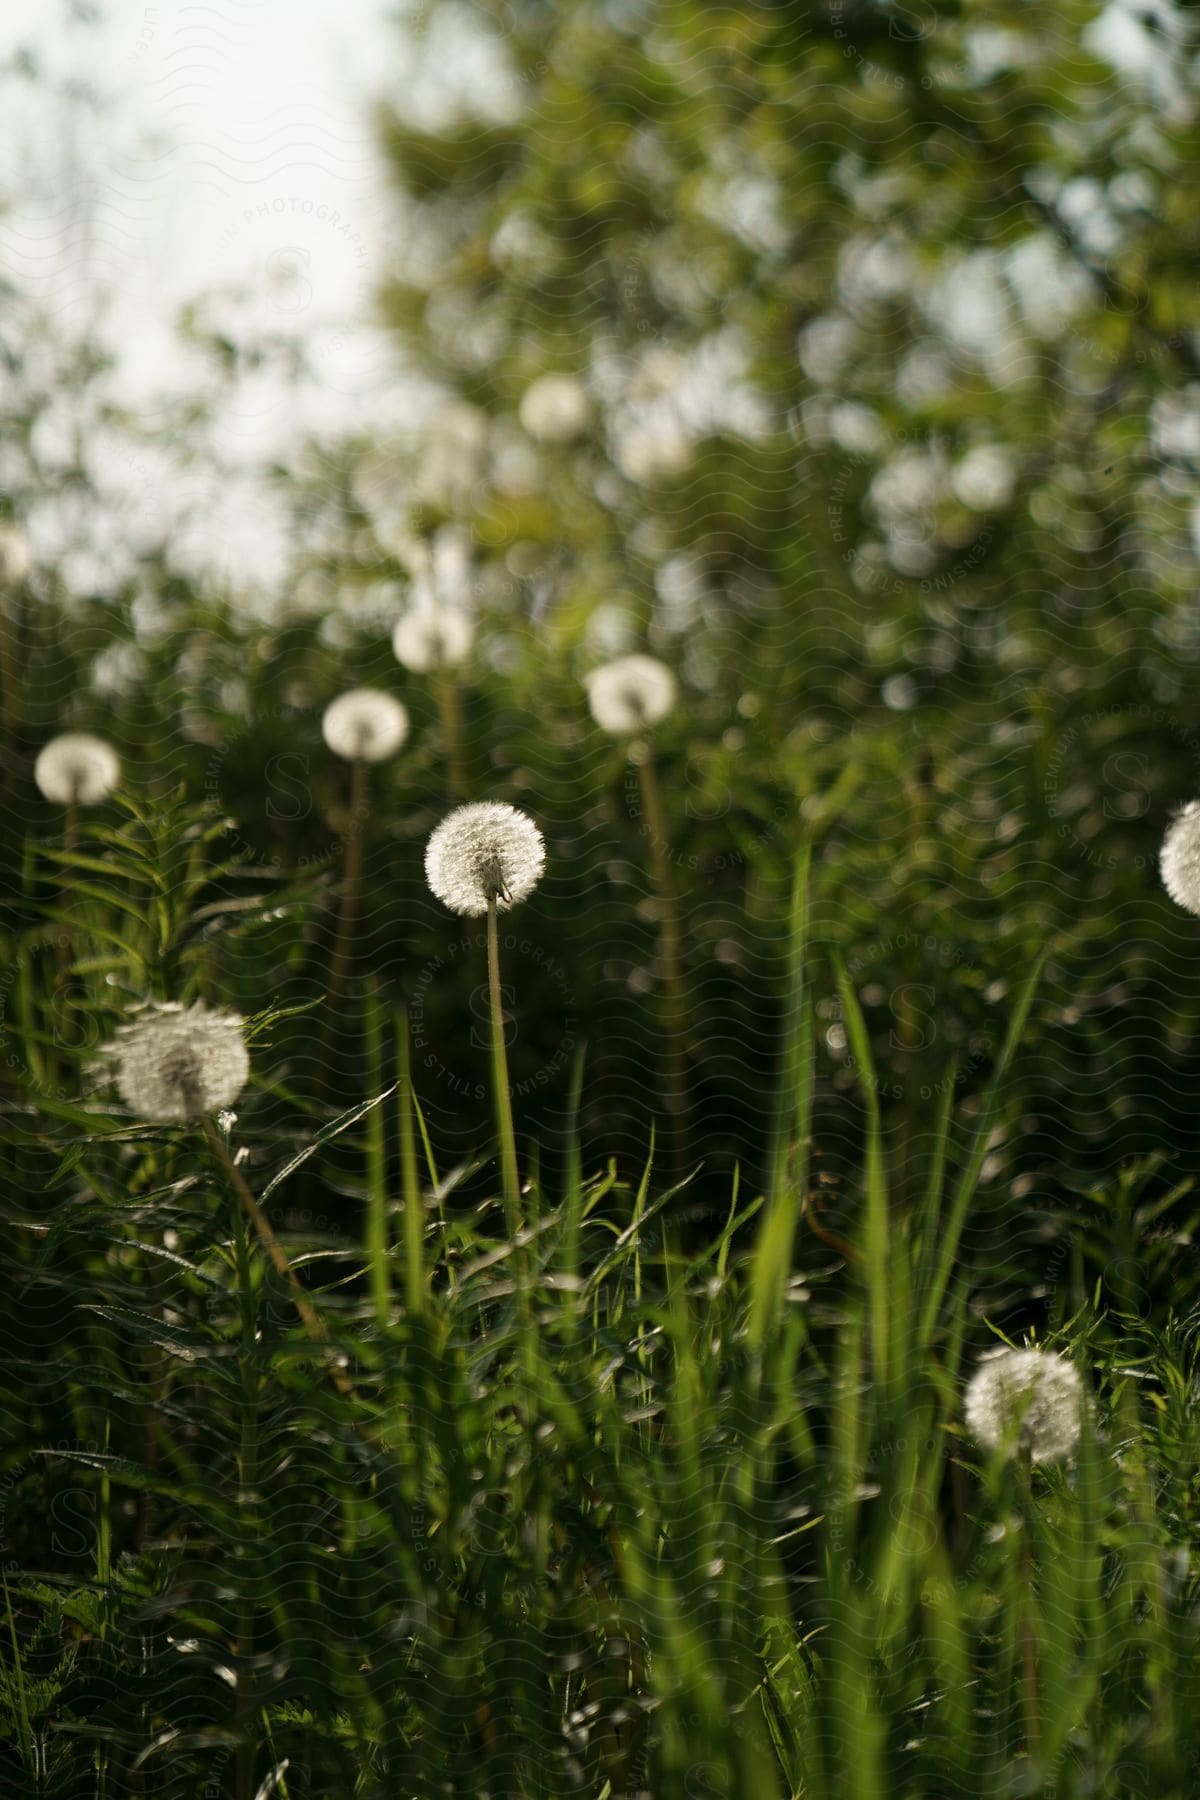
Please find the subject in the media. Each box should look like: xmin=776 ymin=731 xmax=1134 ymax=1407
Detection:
xmin=425 ymin=801 xmax=545 ymax=1235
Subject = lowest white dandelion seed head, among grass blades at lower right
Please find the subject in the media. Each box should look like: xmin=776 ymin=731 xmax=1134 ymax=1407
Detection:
xmin=963 ymin=1350 xmax=1083 ymax=1462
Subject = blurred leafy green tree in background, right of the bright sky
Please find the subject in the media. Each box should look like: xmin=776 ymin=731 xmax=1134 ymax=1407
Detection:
xmin=300 ymin=0 xmax=1200 ymax=1209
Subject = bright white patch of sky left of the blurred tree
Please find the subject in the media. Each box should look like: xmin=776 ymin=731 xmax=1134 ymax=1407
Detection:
xmin=0 ymin=0 xmax=437 ymax=594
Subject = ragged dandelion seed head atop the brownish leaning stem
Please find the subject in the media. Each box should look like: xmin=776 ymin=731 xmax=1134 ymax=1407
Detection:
xmin=104 ymin=1001 xmax=250 ymax=1125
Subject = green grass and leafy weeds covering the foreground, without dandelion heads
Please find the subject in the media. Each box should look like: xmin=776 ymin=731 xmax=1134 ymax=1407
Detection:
xmin=0 ymin=803 xmax=1200 ymax=1800
